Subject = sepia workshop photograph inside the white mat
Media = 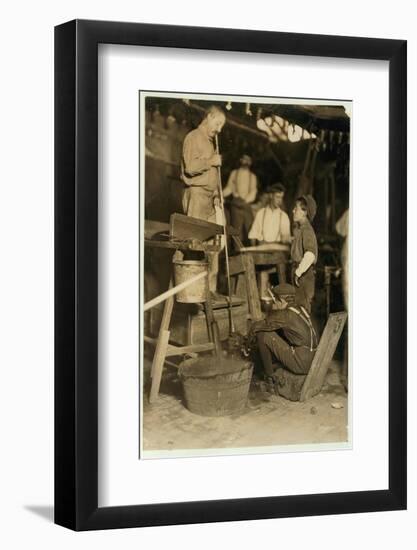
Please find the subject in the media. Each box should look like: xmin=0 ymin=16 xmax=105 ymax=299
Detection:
xmin=138 ymin=90 xmax=352 ymax=459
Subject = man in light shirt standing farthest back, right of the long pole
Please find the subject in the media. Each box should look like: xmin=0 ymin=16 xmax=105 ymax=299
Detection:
xmin=223 ymin=155 xmax=258 ymax=243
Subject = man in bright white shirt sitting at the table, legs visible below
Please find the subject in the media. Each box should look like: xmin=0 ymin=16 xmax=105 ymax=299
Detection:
xmin=249 ymin=183 xmax=291 ymax=298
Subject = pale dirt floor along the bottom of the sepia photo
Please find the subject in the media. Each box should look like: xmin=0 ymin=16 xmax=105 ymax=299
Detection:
xmin=143 ymin=361 xmax=348 ymax=457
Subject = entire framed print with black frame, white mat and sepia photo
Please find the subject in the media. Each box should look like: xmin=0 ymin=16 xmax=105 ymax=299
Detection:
xmin=55 ymin=21 xmax=406 ymax=530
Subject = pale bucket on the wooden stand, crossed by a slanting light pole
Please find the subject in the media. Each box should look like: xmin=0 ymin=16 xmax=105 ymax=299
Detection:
xmin=173 ymin=260 xmax=208 ymax=304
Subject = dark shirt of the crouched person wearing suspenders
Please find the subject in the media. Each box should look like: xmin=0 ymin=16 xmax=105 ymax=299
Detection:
xmin=252 ymin=305 xmax=318 ymax=350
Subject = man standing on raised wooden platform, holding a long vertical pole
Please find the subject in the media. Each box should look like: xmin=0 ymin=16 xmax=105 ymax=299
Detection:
xmin=181 ymin=106 xmax=226 ymax=293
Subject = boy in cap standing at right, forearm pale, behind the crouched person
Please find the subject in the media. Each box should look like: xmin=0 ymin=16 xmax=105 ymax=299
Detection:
xmin=291 ymin=195 xmax=318 ymax=313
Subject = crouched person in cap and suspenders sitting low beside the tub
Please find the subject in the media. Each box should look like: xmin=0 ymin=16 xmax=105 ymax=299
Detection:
xmin=250 ymin=283 xmax=318 ymax=392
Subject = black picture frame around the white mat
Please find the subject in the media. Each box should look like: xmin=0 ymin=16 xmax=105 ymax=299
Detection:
xmin=55 ymin=20 xmax=407 ymax=530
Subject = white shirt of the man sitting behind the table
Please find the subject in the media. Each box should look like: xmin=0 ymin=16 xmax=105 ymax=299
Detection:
xmin=248 ymin=206 xmax=291 ymax=243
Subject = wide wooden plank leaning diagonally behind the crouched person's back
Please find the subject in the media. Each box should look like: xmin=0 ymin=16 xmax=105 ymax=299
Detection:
xmin=300 ymin=311 xmax=347 ymax=401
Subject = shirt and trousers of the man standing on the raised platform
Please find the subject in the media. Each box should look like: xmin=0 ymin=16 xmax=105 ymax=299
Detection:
xmin=181 ymin=125 xmax=219 ymax=220
